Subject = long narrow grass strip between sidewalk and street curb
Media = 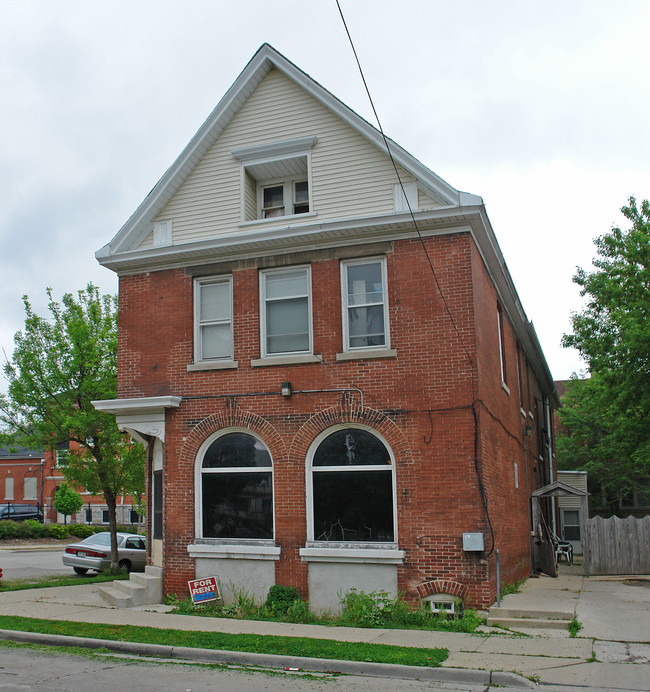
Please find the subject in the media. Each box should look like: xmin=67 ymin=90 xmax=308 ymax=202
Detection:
xmin=0 ymin=615 xmax=448 ymax=668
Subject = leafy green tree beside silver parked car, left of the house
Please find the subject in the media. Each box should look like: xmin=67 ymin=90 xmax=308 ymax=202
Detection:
xmin=0 ymin=284 xmax=144 ymax=566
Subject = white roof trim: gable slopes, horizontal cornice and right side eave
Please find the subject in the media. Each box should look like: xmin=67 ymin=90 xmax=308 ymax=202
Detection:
xmin=95 ymin=43 xmax=559 ymax=407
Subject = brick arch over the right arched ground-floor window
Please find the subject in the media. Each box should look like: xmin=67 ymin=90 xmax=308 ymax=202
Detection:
xmin=289 ymin=400 xmax=413 ymax=465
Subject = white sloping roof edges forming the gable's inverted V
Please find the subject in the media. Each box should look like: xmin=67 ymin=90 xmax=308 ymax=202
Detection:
xmin=95 ymin=43 xmax=482 ymax=269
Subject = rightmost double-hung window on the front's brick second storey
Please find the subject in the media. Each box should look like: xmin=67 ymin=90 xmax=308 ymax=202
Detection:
xmin=341 ymin=258 xmax=390 ymax=351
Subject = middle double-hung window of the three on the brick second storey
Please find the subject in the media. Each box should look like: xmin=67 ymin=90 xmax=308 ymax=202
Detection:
xmin=260 ymin=267 xmax=312 ymax=357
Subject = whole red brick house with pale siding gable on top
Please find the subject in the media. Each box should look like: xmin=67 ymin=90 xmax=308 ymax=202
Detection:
xmin=96 ymin=45 xmax=557 ymax=609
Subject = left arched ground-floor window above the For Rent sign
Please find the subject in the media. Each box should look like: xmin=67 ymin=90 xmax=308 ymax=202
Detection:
xmin=200 ymin=432 xmax=273 ymax=538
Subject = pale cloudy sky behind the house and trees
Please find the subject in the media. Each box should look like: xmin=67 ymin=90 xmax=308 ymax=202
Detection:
xmin=0 ymin=0 xmax=650 ymax=389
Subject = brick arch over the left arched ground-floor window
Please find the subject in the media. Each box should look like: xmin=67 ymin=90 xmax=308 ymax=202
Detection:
xmin=180 ymin=402 xmax=287 ymax=466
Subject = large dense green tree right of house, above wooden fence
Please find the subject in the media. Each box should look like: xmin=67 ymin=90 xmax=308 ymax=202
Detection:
xmin=557 ymin=197 xmax=650 ymax=506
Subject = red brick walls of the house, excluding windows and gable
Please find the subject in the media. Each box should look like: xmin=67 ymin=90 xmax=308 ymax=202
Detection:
xmin=118 ymin=233 xmax=548 ymax=605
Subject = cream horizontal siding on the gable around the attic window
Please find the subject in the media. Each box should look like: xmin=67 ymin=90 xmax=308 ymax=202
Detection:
xmin=140 ymin=70 xmax=441 ymax=249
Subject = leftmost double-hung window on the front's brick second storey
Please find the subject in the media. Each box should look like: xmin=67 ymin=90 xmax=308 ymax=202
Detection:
xmin=194 ymin=276 xmax=233 ymax=362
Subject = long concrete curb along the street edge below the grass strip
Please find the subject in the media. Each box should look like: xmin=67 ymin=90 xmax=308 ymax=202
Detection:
xmin=0 ymin=630 xmax=536 ymax=688
